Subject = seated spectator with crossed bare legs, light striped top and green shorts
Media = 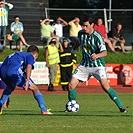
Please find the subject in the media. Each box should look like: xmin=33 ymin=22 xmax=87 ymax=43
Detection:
xmin=11 ymin=16 xmax=29 ymax=51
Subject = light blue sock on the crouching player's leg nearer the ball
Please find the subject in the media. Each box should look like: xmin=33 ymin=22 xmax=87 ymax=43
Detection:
xmin=34 ymin=92 xmax=47 ymax=112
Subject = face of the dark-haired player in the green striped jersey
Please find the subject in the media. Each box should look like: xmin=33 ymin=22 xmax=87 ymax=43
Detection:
xmin=83 ymin=21 xmax=94 ymax=34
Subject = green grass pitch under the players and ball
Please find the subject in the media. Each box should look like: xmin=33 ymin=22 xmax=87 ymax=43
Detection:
xmin=0 ymin=94 xmax=133 ymax=133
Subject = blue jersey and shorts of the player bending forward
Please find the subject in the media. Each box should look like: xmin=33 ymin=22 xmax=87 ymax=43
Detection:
xmin=0 ymin=52 xmax=35 ymax=89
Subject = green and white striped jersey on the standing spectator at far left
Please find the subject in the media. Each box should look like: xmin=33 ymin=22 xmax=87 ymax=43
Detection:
xmin=0 ymin=4 xmax=13 ymax=26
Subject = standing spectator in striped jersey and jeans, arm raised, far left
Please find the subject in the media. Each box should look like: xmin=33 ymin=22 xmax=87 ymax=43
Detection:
xmin=0 ymin=0 xmax=13 ymax=48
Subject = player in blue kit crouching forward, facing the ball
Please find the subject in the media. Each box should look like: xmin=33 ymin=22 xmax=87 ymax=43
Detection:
xmin=0 ymin=45 xmax=52 ymax=115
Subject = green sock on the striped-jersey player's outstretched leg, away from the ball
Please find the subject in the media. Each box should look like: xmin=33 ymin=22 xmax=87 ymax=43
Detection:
xmin=107 ymin=88 xmax=124 ymax=108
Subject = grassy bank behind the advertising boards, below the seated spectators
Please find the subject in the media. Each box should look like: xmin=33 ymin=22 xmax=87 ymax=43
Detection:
xmin=0 ymin=48 xmax=133 ymax=64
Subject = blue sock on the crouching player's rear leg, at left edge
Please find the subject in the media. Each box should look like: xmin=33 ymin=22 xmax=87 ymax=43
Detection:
xmin=0 ymin=88 xmax=12 ymax=108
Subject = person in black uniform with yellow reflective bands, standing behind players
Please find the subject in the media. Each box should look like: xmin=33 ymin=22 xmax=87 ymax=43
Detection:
xmin=59 ymin=38 xmax=76 ymax=91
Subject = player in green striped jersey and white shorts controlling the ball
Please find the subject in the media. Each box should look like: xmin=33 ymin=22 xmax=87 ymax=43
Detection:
xmin=68 ymin=16 xmax=127 ymax=112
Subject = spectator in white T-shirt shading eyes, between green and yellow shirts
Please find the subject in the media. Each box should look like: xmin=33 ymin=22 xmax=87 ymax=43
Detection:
xmin=52 ymin=17 xmax=68 ymax=38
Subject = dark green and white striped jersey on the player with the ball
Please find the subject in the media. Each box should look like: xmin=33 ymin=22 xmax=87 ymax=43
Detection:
xmin=78 ymin=30 xmax=106 ymax=67
